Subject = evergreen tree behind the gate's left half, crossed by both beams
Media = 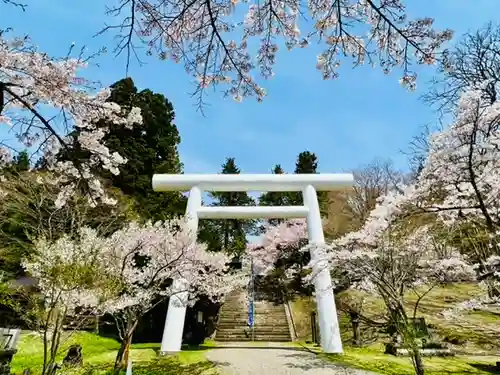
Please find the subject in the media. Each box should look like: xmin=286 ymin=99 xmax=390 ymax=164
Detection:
xmin=198 ymin=158 xmax=257 ymax=258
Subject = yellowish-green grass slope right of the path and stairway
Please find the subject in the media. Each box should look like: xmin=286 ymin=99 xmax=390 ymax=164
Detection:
xmin=292 ymin=284 xmax=500 ymax=375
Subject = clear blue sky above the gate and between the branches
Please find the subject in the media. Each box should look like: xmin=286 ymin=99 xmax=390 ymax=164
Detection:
xmin=0 ymin=0 xmax=498 ymax=178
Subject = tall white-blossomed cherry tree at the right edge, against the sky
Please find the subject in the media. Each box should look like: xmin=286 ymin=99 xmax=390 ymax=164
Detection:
xmin=416 ymin=81 xmax=500 ymax=297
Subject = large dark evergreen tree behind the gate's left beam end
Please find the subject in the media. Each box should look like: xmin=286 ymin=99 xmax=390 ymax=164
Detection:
xmin=54 ymin=78 xmax=186 ymax=221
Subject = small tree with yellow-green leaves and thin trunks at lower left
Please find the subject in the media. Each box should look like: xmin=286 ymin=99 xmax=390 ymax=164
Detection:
xmin=23 ymin=228 xmax=111 ymax=375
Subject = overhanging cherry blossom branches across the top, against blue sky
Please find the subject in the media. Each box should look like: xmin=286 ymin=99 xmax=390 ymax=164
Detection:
xmin=97 ymin=0 xmax=453 ymax=101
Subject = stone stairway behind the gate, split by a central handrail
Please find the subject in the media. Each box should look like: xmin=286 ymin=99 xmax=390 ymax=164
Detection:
xmin=215 ymin=292 xmax=292 ymax=342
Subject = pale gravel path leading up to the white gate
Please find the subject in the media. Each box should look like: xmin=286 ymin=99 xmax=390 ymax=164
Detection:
xmin=207 ymin=346 xmax=377 ymax=375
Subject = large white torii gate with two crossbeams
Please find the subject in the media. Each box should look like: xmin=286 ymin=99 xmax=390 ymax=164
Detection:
xmin=153 ymin=174 xmax=354 ymax=353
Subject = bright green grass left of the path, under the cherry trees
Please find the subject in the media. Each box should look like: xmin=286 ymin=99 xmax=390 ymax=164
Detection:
xmin=11 ymin=332 xmax=216 ymax=375
